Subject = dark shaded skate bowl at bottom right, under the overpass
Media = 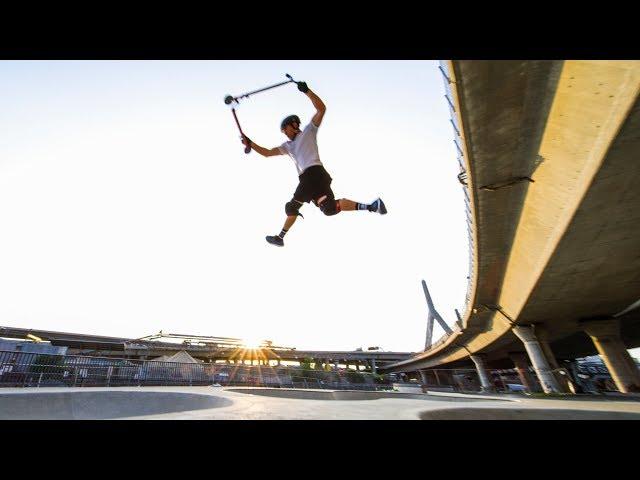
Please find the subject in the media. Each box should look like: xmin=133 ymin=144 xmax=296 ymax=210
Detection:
xmin=420 ymin=407 xmax=640 ymax=420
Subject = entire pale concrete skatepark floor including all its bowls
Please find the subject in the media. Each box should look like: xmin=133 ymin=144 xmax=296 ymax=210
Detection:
xmin=0 ymin=386 xmax=640 ymax=420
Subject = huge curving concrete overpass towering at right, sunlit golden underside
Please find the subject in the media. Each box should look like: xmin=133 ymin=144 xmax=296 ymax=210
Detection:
xmin=385 ymin=61 xmax=640 ymax=392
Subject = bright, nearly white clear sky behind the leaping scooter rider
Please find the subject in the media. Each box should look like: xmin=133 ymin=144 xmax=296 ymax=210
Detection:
xmin=0 ymin=61 xmax=468 ymax=351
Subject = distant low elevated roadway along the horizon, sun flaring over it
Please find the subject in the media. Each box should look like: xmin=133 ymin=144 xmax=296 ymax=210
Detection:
xmin=0 ymin=327 xmax=414 ymax=372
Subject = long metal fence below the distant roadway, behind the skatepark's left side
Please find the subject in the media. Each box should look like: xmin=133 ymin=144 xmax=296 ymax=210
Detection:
xmin=0 ymin=351 xmax=397 ymax=390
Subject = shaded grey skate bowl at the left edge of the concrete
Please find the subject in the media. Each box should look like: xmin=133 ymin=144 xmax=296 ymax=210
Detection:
xmin=0 ymin=390 xmax=233 ymax=420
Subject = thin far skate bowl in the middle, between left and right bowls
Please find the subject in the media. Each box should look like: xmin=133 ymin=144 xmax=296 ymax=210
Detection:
xmin=225 ymin=387 xmax=502 ymax=402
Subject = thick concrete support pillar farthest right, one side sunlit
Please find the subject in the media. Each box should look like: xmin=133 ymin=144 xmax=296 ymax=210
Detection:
xmin=582 ymin=319 xmax=640 ymax=393
